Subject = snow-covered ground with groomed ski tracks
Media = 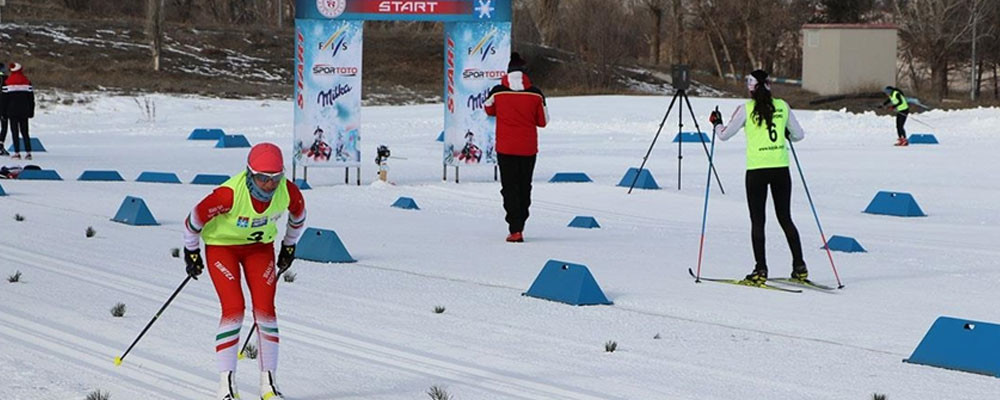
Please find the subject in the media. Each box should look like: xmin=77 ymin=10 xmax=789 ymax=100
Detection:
xmin=0 ymin=92 xmax=1000 ymax=400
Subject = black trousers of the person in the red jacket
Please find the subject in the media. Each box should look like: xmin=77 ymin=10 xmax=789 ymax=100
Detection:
xmin=497 ymin=153 xmax=537 ymax=233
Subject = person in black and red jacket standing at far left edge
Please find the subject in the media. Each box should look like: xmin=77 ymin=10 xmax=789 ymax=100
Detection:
xmin=0 ymin=63 xmax=35 ymax=160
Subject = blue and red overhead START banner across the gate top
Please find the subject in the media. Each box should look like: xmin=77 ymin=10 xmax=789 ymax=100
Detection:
xmin=295 ymin=0 xmax=511 ymax=22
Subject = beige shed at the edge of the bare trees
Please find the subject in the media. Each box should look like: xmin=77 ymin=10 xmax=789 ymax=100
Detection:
xmin=802 ymin=24 xmax=898 ymax=95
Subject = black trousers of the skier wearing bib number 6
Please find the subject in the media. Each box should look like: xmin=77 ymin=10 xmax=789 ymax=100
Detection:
xmin=746 ymin=167 xmax=806 ymax=269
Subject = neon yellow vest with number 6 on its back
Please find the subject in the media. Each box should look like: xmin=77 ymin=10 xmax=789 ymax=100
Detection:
xmin=743 ymin=99 xmax=789 ymax=170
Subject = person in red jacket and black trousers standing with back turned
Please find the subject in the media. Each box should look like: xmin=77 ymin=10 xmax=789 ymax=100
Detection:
xmin=485 ymin=52 xmax=549 ymax=243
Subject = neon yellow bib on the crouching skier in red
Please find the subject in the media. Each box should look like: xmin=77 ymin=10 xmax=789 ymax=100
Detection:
xmin=201 ymin=171 xmax=290 ymax=246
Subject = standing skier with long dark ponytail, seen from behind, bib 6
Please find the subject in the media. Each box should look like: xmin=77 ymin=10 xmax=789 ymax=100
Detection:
xmin=709 ymin=70 xmax=809 ymax=286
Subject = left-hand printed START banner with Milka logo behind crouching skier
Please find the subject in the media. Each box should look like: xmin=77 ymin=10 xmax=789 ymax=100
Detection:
xmin=292 ymin=19 xmax=364 ymax=167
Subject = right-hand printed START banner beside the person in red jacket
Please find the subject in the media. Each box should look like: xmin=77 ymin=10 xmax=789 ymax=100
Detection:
xmin=444 ymin=22 xmax=511 ymax=166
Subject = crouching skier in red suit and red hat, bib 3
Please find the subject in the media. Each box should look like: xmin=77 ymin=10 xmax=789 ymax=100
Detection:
xmin=184 ymin=143 xmax=306 ymax=400
